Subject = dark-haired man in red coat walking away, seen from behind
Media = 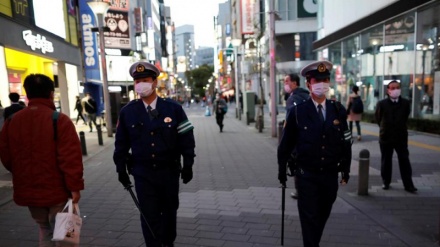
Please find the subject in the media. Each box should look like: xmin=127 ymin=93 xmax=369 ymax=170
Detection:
xmin=0 ymin=74 xmax=84 ymax=246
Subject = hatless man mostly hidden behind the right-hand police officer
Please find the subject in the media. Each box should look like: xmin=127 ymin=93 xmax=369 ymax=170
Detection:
xmin=284 ymin=74 xmax=310 ymax=199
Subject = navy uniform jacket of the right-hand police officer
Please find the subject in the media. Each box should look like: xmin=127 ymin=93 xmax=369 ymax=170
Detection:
xmin=278 ymin=98 xmax=351 ymax=174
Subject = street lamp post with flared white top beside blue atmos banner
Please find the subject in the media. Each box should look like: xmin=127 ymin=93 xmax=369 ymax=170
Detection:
xmin=87 ymin=0 xmax=113 ymax=137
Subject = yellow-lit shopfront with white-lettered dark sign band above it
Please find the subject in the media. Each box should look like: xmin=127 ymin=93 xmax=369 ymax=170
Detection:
xmin=0 ymin=17 xmax=81 ymax=116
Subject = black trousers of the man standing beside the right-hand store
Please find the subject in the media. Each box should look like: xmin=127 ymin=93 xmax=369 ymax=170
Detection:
xmin=380 ymin=142 xmax=414 ymax=189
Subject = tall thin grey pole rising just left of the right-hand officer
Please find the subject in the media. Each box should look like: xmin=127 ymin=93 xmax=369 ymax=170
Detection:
xmin=269 ymin=0 xmax=277 ymax=137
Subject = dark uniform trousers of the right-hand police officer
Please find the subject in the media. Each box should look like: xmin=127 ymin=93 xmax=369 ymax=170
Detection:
xmin=296 ymin=169 xmax=339 ymax=247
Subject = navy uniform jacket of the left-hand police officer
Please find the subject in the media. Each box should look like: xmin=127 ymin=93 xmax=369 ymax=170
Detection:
xmin=113 ymin=97 xmax=195 ymax=176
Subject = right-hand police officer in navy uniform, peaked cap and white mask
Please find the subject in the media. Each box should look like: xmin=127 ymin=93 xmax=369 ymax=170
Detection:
xmin=278 ymin=61 xmax=352 ymax=247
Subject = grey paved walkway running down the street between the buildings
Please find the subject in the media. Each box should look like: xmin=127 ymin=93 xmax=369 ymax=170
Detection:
xmin=0 ymin=105 xmax=440 ymax=247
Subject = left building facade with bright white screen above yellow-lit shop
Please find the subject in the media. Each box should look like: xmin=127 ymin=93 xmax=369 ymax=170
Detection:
xmin=0 ymin=0 xmax=82 ymax=116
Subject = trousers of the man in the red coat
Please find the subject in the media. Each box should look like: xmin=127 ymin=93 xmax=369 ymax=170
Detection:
xmin=28 ymin=202 xmax=79 ymax=247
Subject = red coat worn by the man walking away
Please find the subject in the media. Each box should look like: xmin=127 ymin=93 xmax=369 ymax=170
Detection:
xmin=0 ymin=99 xmax=84 ymax=207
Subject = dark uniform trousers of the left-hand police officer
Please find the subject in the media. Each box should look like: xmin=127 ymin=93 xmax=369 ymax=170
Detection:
xmin=134 ymin=169 xmax=180 ymax=247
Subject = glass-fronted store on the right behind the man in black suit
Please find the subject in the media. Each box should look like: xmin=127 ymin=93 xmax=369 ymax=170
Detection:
xmin=314 ymin=1 xmax=440 ymax=119
